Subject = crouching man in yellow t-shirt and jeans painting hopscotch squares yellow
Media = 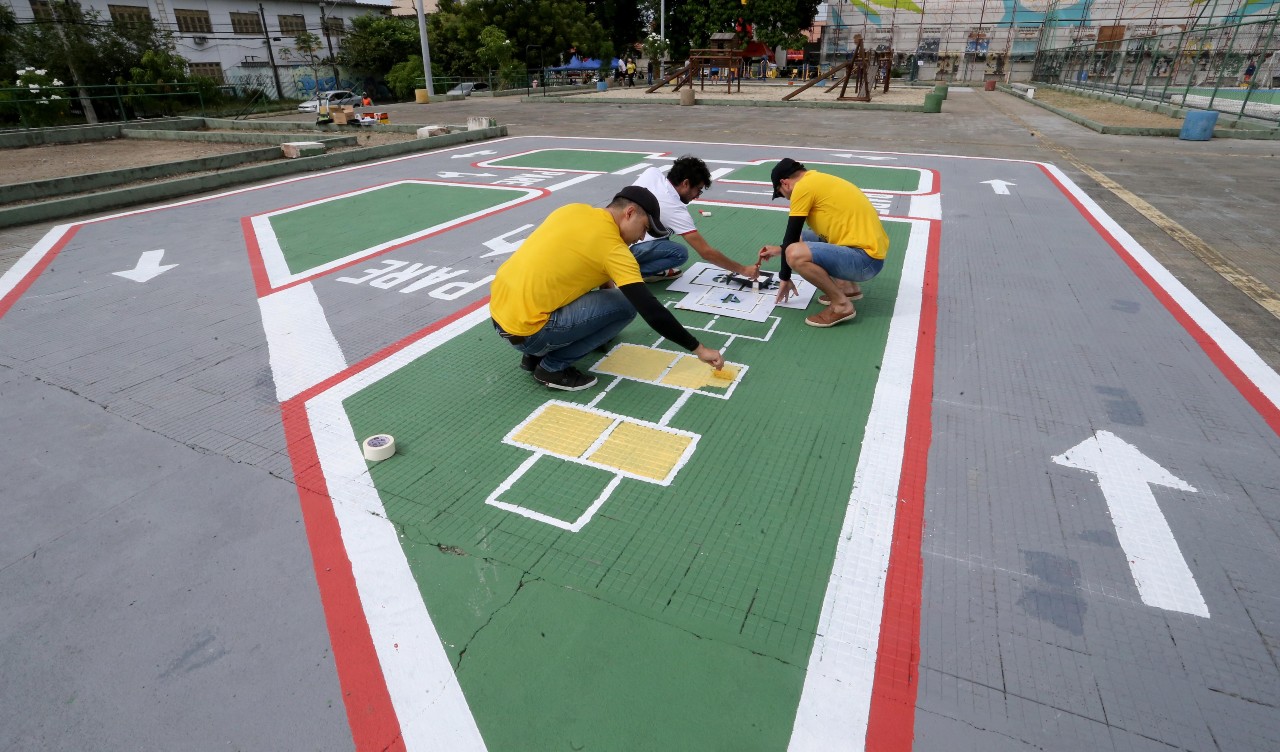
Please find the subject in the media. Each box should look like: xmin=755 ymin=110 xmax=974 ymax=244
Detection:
xmin=489 ymin=185 xmax=724 ymax=391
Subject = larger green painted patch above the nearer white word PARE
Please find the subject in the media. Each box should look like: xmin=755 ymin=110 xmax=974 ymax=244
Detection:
xmin=271 ymin=183 xmax=527 ymax=274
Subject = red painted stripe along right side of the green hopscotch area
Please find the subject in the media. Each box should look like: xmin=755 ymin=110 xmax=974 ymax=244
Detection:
xmin=867 ymin=220 xmax=942 ymax=752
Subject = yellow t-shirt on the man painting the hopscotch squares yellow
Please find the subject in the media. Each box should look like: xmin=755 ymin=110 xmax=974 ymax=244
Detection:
xmin=489 ymin=203 xmax=641 ymax=336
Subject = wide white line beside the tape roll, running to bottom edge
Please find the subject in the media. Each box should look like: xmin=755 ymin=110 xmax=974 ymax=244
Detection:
xmin=307 ymin=390 xmax=485 ymax=751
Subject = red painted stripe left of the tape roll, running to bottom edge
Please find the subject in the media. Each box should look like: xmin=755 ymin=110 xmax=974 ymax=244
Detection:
xmin=280 ymin=398 xmax=404 ymax=749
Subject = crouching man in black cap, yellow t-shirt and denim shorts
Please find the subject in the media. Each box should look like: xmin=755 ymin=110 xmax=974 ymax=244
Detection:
xmin=760 ymin=157 xmax=888 ymax=329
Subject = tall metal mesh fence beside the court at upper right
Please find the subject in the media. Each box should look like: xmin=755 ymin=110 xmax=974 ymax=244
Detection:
xmin=1032 ymin=18 xmax=1280 ymax=123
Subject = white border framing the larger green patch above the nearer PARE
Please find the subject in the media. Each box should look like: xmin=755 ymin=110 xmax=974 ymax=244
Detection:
xmin=250 ymin=179 xmax=543 ymax=289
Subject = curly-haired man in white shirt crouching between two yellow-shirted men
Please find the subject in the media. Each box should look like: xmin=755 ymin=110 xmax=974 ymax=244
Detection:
xmin=631 ymin=156 xmax=760 ymax=283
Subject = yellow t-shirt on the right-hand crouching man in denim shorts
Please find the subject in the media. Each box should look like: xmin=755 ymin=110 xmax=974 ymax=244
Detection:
xmin=791 ymin=170 xmax=888 ymax=258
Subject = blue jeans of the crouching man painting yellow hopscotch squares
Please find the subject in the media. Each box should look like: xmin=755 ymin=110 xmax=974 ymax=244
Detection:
xmin=501 ymin=288 xmax=636 ymax=373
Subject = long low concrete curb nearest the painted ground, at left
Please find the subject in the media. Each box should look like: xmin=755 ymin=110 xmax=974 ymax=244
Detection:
xmin=0 ymin=125 xmax=507 ymax=228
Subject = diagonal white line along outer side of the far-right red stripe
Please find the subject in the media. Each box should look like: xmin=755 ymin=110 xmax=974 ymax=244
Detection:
xmin=1034 ymin=162 xmax=1280 ymax=409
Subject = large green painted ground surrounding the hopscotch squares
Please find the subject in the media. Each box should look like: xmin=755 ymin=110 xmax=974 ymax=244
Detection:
xmin=344 ymin=206 xmax=909 ymax=749
